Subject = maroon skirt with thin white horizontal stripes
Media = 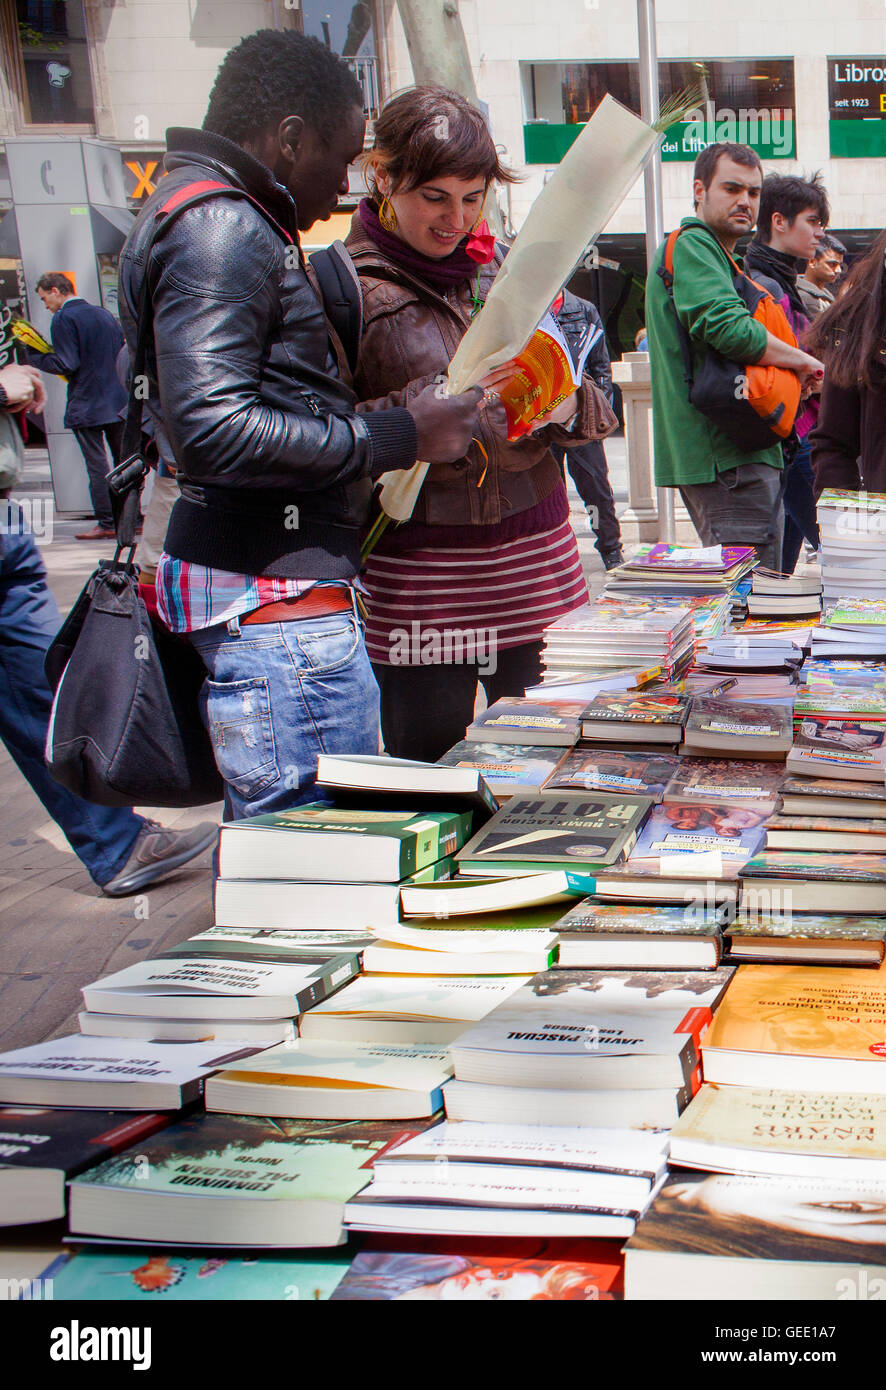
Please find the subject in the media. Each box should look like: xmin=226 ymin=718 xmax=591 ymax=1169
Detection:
xmin=363 ymin=521 xmax=587 ymax=666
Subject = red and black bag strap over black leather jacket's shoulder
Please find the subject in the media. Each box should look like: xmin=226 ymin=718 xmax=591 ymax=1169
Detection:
xmin=107 ymin=179 xmax=294 ymax=558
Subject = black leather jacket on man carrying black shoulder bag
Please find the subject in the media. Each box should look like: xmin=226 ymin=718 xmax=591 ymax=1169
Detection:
xmin=120 ymin=129 xmax=416 ymax=578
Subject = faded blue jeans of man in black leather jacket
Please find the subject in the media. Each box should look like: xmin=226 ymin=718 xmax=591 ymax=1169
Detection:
xmin=188 ymin=613 xmax=378 ymax=820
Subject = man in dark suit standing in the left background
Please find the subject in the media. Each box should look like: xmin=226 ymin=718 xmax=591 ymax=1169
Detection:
xmin=25 ymin=271 xmax=127 ymax=541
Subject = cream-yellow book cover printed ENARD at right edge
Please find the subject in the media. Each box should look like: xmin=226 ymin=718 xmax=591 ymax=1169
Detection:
xmin=670 ymin=1081 xmax=886 ymax=1159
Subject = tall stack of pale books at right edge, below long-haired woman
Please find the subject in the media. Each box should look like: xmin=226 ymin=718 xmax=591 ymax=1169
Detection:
xmin=816 ymin=488 xmax=886 ymax=605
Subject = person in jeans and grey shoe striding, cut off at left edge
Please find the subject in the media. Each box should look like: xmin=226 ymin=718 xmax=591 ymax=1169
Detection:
xmin=0 ymin=366 xmax=218 ymax=898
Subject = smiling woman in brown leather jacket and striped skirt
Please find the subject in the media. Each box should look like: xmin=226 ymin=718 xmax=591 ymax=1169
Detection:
xmin=345 ymin=88 xmax=615 ymax=760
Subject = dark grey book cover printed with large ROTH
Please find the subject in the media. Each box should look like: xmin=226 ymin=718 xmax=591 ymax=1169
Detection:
xmin=456 ymin=792 xmax=652 ymax=872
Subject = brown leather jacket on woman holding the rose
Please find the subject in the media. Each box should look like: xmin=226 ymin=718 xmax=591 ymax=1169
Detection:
xmin=345 ymin=213 xmax=616 ymax=525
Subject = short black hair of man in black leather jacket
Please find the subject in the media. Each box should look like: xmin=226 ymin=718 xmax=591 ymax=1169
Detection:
xmin=203 ymin=29 xmax=363 ymax=143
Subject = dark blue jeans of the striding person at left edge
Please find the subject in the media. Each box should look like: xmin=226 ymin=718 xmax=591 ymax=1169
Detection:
xmin=0 ymin=502 xmax=145 ymax=884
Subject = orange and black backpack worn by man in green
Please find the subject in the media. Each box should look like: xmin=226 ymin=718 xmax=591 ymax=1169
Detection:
xmin=658 ymin=227 xmax=801 ymax=453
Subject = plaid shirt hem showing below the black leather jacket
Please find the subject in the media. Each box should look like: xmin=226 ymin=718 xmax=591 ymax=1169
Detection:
xmin=157 ymin=550 xmax=317 ymax=632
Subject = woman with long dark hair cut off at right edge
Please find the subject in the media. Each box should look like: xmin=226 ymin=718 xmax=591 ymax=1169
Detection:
xmin=805 ymin=232 xmax=886 ymax=495
